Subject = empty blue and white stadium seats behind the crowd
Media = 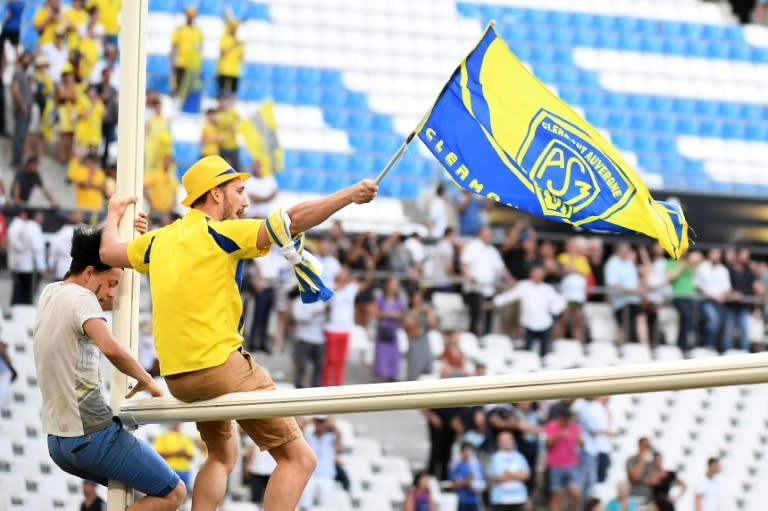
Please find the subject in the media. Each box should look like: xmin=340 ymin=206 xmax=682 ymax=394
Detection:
xmin=0 ymin=0 xmax=768 ymax=511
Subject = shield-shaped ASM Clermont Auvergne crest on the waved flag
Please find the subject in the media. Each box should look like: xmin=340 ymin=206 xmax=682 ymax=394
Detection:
xmin=515 ymin=109 xmax=635 ymax=224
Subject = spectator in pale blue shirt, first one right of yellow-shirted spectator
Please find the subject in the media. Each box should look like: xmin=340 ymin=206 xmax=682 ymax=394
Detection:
xmin=604 ymin=242 xmax=640 ymax=342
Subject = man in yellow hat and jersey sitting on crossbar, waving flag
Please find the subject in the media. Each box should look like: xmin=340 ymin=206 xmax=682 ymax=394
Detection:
xmin=100 ymin=156 xmax=377 ymax=511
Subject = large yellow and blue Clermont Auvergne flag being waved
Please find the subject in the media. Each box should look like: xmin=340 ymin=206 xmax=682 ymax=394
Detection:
xmin=417 ymin=23 xmax=688 ymax=258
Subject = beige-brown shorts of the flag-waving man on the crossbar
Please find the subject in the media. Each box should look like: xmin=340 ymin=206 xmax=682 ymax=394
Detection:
xmin=165 ymin=351 xmax=302 ymax=451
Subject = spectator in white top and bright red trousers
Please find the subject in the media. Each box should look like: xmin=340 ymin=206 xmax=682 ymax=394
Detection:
xmin=322 ymin=266 xmax=359 ymax=387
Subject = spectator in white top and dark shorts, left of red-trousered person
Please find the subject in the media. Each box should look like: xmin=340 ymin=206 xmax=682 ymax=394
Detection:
xmin=292 ymin=297 xmax=325 ymax=389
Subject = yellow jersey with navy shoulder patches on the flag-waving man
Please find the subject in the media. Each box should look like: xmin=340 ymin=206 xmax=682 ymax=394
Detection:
xmin=128 ymin=209 xmax=270 ymax=376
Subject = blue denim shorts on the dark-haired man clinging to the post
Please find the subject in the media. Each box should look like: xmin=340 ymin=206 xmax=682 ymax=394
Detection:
xmin=48 ymin=418 xmax=179 ymax=497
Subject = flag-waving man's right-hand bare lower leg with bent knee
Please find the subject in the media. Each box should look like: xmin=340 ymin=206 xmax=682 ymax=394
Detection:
xmin=266 ymin=437 xmax=317 ymax=511
